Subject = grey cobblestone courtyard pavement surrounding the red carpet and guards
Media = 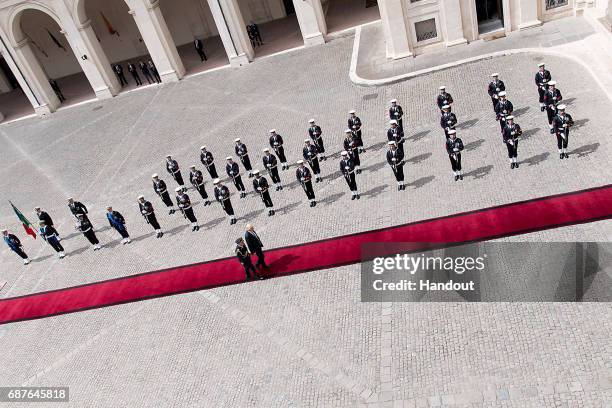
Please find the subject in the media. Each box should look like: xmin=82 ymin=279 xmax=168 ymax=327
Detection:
xmin=0 ymin=30 xmax=612 ymax=407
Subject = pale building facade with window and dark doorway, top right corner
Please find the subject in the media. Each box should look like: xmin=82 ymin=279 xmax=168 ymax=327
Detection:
xmin=379 ymin=0 xmax=609 ymax=59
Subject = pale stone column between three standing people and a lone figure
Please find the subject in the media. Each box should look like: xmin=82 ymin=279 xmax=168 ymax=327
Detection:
xmin=127 ymin=0 xmax=185 ymax=82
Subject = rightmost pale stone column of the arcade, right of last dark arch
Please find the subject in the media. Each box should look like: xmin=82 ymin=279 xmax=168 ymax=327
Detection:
xmin=378 ymin=0 xmax=412 ymax=59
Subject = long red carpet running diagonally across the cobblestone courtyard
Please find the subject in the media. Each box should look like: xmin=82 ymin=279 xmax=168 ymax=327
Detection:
xmin=0 ymin=185 xmax=612 ymax=324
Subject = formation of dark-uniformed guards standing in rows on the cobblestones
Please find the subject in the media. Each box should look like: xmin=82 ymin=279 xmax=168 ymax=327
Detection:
xmin=2 ymin=64 xmax=574 ymax=264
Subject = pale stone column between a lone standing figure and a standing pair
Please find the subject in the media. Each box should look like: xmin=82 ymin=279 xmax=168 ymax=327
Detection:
xmin=208 ymin=0 xmax=255 ymax=67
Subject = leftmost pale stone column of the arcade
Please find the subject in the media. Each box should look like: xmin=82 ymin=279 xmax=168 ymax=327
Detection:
xmin=7 ymin=38 xmax=61 ymax=116
